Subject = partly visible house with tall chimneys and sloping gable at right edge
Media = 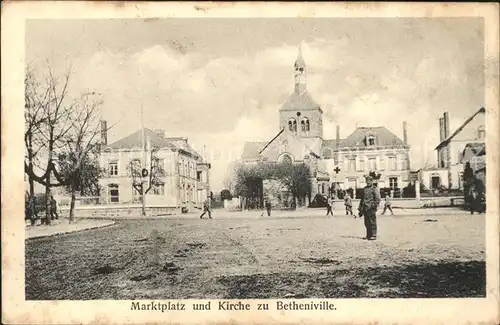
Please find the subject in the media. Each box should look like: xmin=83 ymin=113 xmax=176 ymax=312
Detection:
xmin=436 ymin=108 xmax=486 ymax=190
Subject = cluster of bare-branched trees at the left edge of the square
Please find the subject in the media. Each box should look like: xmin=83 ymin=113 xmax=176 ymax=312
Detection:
xmin=24 ymin=65 xmax=102 ymax=224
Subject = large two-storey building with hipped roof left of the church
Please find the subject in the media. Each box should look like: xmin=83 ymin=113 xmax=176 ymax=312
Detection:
xmin=100 ymin=125 xmax=210 ymax=210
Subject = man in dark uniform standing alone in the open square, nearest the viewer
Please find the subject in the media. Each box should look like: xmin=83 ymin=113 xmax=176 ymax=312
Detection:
xmin=359 ymin=176 xmax=380 ymax=240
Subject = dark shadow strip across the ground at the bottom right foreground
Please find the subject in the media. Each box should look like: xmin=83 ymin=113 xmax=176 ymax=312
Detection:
xmin=218 ymin=261 xmax=486 ymax=299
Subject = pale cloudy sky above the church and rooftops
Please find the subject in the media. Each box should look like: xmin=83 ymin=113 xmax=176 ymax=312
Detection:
xmin=26 ymin=18 xmax=484 ymax=191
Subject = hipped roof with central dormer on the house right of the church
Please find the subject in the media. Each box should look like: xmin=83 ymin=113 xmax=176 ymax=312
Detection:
xmin=341 ymin=126 xmax=405 ymax=148
